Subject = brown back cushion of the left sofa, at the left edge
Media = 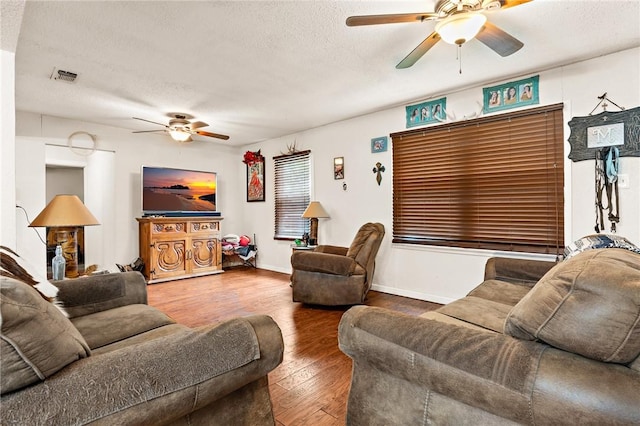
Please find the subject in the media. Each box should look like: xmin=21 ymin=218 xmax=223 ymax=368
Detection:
xmin=0 ymin=277 xmax=91 ymax=394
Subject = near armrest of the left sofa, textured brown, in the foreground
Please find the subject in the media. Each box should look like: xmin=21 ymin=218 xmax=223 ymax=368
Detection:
xmin=0 ymin=315 xmax=284 ymax=425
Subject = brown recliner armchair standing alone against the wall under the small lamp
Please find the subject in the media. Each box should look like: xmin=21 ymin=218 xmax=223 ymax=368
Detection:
xmin=291 ymin=223 xmax=384 ymax=305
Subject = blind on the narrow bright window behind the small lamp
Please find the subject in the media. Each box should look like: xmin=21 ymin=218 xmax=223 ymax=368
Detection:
xmin=273 ymin=151 xmax=311 ymax=240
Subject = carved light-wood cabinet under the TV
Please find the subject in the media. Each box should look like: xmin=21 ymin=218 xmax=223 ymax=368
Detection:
xmin=136 ymin=217 xmax=224 ymax=284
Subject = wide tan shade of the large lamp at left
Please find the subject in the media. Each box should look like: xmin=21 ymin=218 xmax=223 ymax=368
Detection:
xmin=29 ymin=195 xmax=100 ymax=227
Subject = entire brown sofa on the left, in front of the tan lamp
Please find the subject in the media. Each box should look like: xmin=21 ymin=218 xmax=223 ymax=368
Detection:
xmin=0 ymin=271 xmax=284 ymax=425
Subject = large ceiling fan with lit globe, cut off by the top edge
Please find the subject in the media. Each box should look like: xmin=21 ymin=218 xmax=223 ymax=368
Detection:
xmin=347 ymin=0 xmax=531 ymax=68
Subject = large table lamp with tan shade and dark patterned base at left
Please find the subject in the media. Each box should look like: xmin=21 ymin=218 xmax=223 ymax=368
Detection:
xmin=29 ymin=195 xmax=100 ymax=278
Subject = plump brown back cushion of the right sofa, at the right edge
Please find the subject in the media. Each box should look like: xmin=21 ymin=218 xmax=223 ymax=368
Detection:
xmin=504 ymin=248 xmax=640 ymax=363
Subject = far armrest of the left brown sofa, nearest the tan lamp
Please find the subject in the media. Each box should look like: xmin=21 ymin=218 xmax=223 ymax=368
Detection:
xmin=55 ymin=272 xmax=147 ymax=318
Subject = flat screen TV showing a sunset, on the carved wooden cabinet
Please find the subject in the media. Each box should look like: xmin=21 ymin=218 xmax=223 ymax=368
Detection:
xmin=141 ymin=166 xmax=220 ymax=216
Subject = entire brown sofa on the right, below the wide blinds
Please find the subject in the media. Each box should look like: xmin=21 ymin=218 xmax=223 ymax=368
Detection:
xmin=339 ymin=248 xmax=640 ymax=426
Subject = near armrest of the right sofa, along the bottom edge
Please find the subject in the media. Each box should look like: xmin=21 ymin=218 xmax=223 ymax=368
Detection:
xmin=338 ymin=306 xmax=640 ymax=424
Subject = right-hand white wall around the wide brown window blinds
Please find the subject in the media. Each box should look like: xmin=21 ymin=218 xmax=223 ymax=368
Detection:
xmin=245 ymin=49 xmax=640 ymax=303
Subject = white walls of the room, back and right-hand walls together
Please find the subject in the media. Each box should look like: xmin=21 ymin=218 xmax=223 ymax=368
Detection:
xmin=11 ymin=49 xmax=640 ymax=303
